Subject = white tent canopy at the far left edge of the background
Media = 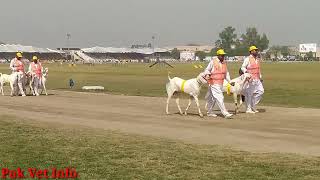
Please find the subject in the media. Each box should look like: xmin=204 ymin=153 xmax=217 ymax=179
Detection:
xmin=0 ymin=44 xmax=63 ymax=53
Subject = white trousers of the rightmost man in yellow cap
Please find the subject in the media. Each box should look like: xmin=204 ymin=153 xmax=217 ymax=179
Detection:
xmin=245 ymin=80 xmax=264 ymax=110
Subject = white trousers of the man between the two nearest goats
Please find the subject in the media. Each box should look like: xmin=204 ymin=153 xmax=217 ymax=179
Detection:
xmin=207 ymin=84 xmax=229 ymax=116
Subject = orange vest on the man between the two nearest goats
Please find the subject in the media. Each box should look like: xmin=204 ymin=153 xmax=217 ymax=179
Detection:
xmin=208 ymin=59 xmax=227 ymax=85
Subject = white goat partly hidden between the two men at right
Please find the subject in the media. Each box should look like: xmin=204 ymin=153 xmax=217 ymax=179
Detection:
xmin=205 ymin=73 xmax=251 ymax=114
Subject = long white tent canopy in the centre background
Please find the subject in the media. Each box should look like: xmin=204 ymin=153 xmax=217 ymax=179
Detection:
xmin=81 ymin=46 xmax=169 ymax=54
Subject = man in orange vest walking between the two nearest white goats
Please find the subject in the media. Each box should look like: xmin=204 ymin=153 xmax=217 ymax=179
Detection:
xmin=204 ymin=49 xmax=232 ymax=118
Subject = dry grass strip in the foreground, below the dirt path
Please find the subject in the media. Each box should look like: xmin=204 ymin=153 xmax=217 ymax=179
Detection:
xmin=0 ymin=116 xmax=320 ymax=180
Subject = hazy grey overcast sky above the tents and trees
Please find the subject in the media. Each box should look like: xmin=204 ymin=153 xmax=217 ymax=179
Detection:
xmin=0 ymin=0 xmax=320 ymax=48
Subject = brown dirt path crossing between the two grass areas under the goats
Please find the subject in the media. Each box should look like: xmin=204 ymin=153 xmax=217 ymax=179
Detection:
xmin=0 ymin=91 xmax=320 ymax=155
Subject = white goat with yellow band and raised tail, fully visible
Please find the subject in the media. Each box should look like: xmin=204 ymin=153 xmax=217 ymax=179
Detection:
xmin=166 ymin=73 xmax=207 ymax=117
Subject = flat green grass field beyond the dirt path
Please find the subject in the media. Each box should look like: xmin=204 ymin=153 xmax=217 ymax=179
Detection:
xmin=0 ymin=62 xmax=320 ymax=108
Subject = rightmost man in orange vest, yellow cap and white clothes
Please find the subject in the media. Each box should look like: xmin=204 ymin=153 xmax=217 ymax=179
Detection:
xmin=241 ymin=46 xmax=264 ymax=114
